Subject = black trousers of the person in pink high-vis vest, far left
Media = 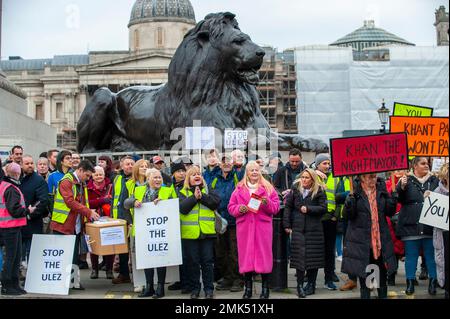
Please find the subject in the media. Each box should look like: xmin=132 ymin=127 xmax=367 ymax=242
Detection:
xmin=0 ymin=227 xmax=22 ymax=288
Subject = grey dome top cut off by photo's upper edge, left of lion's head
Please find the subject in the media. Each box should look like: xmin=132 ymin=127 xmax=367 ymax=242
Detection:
xmin=128 ymin=0 xmax=195 ymax=27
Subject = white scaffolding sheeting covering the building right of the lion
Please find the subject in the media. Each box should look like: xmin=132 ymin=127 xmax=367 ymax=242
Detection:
xmin=296 ymin=46 xmax=449 ymax=143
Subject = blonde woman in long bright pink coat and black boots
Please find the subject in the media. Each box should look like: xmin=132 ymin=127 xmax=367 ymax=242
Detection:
xmin=228 ymin=161 xmax=280 ymax=299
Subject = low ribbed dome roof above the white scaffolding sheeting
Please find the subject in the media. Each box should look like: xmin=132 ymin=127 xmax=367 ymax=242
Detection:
xmin=330 ymin=20 xmax=414 ymax=51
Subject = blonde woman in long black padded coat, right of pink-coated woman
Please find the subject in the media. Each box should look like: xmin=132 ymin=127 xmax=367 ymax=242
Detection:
xmin=283 ymin=168 xmax=327 ymax=298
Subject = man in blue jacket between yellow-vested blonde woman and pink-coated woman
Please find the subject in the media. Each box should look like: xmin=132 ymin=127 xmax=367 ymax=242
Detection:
xmin=208 ymin=156 xmax=242 ymax=292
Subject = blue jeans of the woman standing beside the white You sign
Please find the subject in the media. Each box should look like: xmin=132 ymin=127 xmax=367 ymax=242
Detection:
xmin=404 ymin=238 xmax=437 ymax=279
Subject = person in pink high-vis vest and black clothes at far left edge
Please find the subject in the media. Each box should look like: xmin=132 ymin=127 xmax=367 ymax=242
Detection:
xmin=0 ymin=163 xmax=36 ymax=295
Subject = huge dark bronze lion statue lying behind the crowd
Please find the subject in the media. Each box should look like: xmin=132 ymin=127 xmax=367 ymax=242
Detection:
xmin=77 ymin=12 xmax=270 ymax=153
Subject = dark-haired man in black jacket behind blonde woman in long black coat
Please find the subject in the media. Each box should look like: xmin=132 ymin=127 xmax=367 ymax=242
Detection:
xmin=273 ymin=148 xmax=306 ymax=199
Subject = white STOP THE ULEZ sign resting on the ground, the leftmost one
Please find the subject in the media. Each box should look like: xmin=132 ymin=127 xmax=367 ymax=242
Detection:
xmin=25 ymin=235 xmax=75 ymax=295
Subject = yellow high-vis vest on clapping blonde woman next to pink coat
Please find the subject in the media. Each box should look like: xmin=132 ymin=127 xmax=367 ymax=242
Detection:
xmin=180 ymin=188 xmax=216 ymax=239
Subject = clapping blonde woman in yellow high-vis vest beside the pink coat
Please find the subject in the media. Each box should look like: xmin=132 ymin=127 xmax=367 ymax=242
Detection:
xmin=179 ymin=166 xmax=220 ymax=299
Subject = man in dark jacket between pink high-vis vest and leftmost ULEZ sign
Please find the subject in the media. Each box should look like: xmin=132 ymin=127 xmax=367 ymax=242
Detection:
xmin=19 ymin=155 xmax=48 ymax=263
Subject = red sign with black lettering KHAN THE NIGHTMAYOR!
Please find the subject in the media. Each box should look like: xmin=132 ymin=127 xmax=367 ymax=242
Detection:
xmin=330 ymin=133 xmax=408 ymax=177
